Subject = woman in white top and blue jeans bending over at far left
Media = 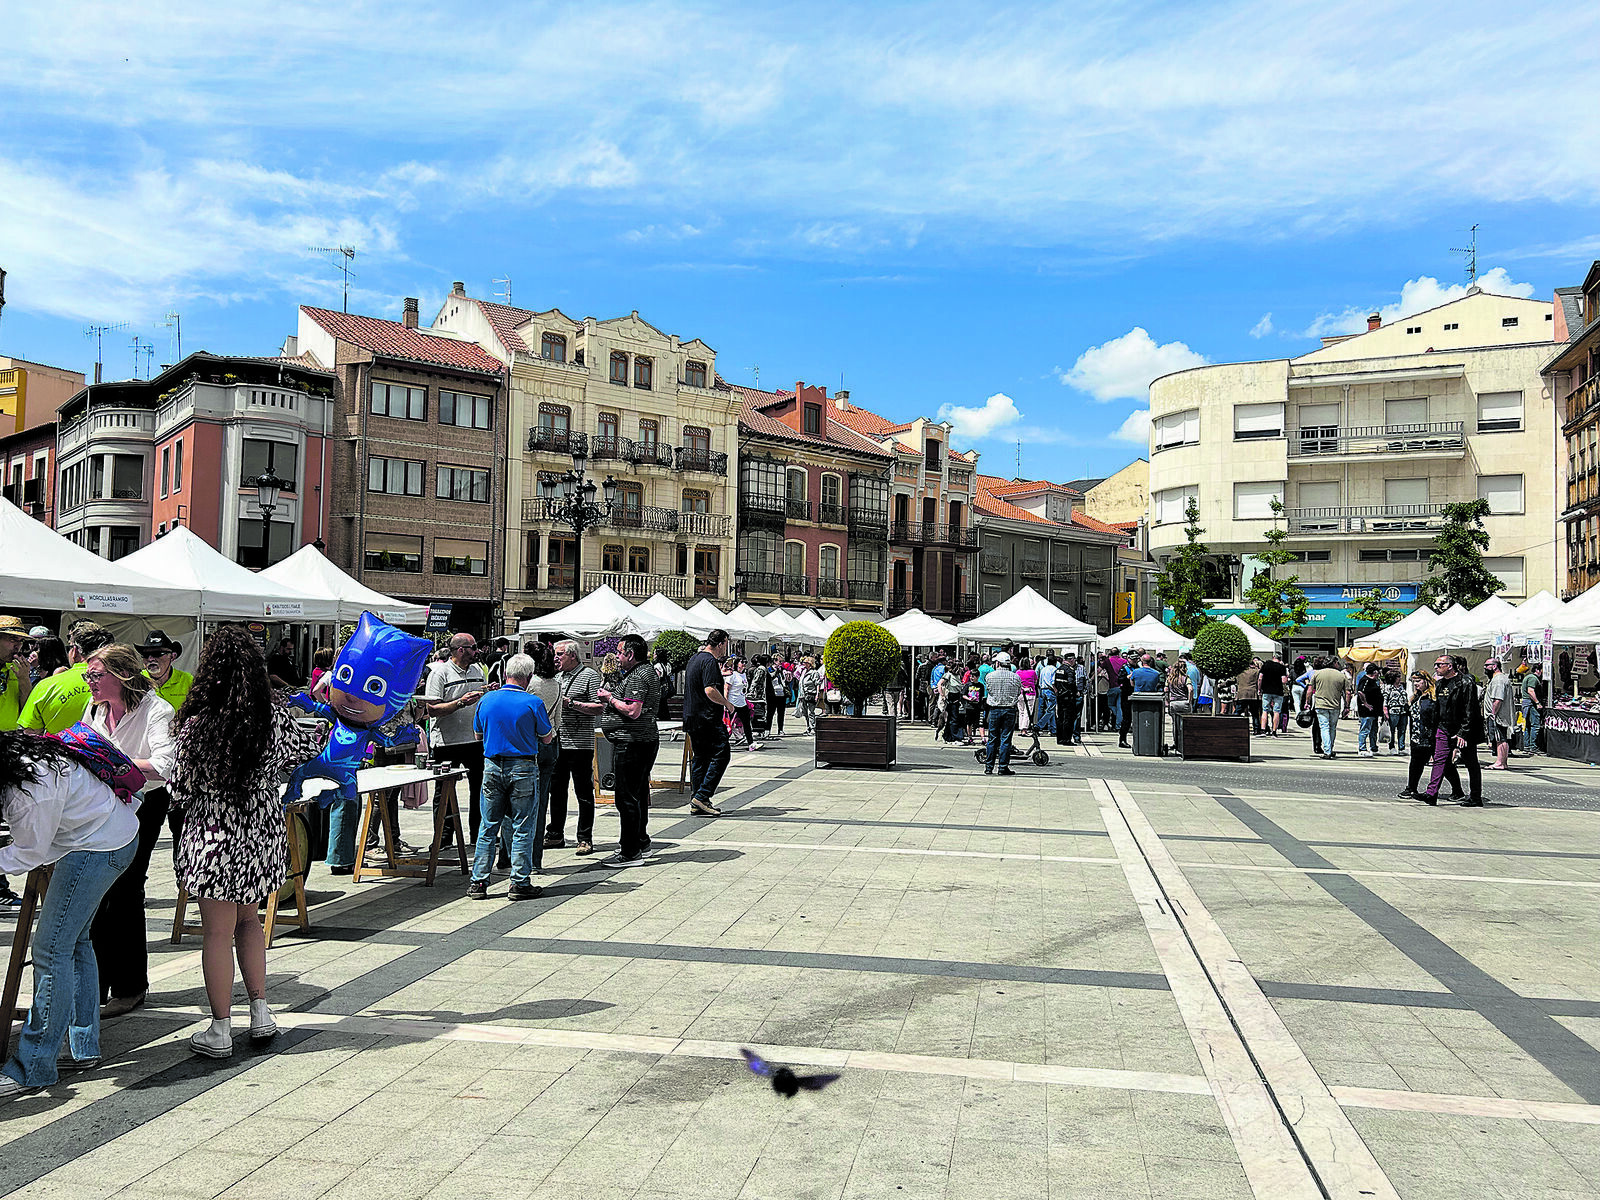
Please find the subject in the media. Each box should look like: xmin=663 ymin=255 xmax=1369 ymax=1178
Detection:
xmin=0 ymin=731 xmax=139 ymax=1099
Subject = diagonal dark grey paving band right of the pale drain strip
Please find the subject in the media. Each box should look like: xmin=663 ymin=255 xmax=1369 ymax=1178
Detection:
xmin=1202 ymin=787 xmax=1600 ymax=1104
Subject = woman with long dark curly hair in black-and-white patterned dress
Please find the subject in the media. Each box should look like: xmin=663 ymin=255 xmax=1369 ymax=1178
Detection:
xmin=170 ymin=626 xmax=322 ymax=1058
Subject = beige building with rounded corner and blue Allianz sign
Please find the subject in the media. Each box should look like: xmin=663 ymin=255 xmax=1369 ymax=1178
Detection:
xmin=1149 ymin=290 xmax=1558 ymax=645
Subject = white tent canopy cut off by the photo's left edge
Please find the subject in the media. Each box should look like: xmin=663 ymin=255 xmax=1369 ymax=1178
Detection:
xmin=0 ymin=499 xmax=203 ymax=618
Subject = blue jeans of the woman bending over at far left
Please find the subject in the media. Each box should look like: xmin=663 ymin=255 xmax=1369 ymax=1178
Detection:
xmin=5 ymin=838 xmax=139 ymax=1088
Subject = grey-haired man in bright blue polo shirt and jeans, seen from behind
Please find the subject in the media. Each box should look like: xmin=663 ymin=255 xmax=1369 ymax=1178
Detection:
xmin=467 ymin=654 xmax=555 ymax=899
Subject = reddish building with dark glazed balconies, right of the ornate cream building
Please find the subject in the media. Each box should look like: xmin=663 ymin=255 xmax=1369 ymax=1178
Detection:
xmin=733 ymin=382 xmax=914 ymax=613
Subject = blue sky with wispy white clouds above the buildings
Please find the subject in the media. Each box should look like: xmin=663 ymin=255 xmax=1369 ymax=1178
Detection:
xmin=0 ymin=0 xmax=1600 ymax=478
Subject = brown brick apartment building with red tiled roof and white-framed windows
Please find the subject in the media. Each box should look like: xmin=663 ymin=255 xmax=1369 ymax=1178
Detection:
xmin=296 ymin=299 xmax=509 ymax=638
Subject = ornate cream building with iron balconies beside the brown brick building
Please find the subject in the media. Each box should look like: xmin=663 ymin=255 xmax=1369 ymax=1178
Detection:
xmin=434 ymin=283 xmax=742 ymax=626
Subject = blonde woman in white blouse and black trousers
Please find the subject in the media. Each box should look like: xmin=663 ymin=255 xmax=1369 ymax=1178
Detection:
xmin=83 ymin=643 xmax=176 ymax=1018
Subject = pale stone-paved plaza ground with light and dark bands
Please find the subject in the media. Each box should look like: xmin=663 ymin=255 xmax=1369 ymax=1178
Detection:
xmin=0 ymin=730 xmax=1600 ymax=1200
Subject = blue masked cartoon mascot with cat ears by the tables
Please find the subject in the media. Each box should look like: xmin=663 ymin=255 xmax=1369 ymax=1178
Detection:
xmin=285 ymin=613 xmax=434 ymax=874
